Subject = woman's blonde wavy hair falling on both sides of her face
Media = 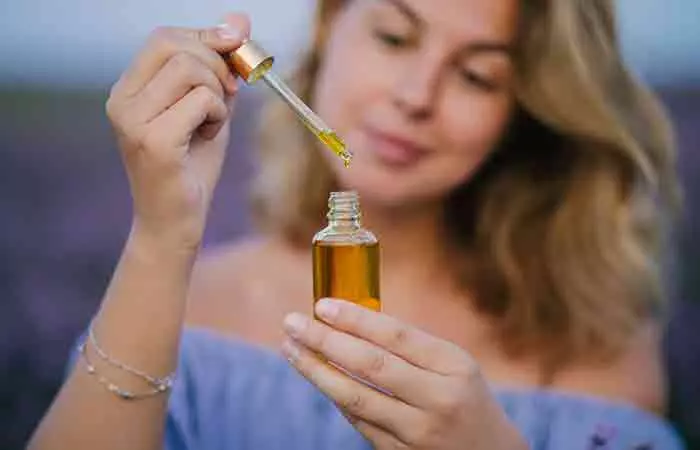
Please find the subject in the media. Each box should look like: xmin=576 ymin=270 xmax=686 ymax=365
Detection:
xmin=247 ymin=0 xmax=679 ymax=368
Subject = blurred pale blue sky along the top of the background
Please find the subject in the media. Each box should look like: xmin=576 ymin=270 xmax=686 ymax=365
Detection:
xmin=0 ymin=0 xmax=700 ymax=86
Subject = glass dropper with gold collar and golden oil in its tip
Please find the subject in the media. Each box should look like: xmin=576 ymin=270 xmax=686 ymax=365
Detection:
xmin=229 ymin=40 xmax=352 ymax=167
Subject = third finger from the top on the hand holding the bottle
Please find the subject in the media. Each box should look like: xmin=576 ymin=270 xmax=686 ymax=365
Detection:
xmin=282 ymin=340 xmax=421 ymax=439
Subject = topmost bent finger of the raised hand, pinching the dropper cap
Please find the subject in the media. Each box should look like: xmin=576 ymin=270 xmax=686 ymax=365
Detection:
xmin=115 ymin=14 xmax=250 ymax=97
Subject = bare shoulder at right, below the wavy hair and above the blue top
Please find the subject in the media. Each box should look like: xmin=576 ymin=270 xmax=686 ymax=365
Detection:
xmin=552 ymin=323 xmax=667 ymax=415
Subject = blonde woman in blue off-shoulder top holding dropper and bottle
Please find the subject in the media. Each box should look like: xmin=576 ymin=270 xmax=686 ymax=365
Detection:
xmin=31 ymin=0 xmax=680 ymax=450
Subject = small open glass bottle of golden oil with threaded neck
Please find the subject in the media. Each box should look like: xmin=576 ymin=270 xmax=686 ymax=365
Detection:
xmin=312 ymin=192 xmax=381 ymax=318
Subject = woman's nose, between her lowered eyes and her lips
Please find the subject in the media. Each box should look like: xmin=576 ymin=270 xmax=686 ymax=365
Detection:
xmin=393 ymin=53 xmax=440 ymax=119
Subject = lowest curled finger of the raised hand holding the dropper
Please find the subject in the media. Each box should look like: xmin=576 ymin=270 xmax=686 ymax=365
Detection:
xmin=145 ymin=86 xmax=228 ymax=155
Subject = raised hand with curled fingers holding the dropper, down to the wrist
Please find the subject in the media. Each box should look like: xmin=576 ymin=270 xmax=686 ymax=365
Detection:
xmin=107 ymin=14 xmax=250 ymax=248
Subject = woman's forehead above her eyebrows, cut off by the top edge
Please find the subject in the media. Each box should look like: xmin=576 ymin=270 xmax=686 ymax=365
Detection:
xmin=367 ymin=0 xmax=516 ymax=41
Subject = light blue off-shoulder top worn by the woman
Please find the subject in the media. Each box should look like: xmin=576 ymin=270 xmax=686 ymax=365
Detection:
xmin=154 ymin=328 xmax=683 ymax=450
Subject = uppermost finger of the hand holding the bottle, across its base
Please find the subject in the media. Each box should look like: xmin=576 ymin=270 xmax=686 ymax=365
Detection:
xmin=316 ymin=299 xmax=478 ymax=376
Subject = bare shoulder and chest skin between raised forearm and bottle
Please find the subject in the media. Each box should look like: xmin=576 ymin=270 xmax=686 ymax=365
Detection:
xmin=186 ymin=238 xmax=305 ymax=346
